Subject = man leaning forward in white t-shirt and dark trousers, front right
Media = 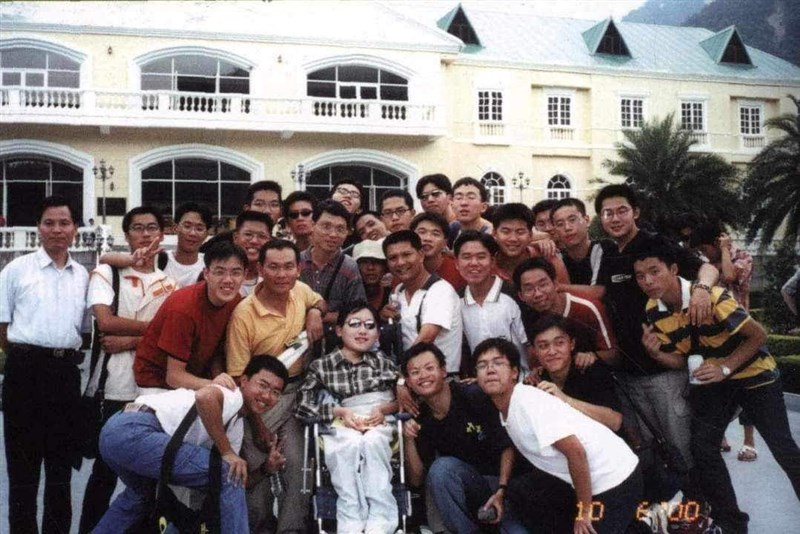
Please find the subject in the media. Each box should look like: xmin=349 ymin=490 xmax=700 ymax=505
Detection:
xmin=475 ymin=338 xmax=642 ymax=534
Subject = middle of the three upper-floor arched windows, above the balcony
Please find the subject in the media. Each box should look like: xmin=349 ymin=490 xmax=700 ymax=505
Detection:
xmin=140 ymin=54 xmax=250 ymax=113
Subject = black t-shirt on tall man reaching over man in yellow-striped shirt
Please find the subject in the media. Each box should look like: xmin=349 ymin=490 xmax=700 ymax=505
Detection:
xmin=597 ymin=230 xmax=703 ymax=375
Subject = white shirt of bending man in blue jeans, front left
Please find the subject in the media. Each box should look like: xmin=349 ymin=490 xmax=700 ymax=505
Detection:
xmin=136 ymin=384 xmax=244 ymax=454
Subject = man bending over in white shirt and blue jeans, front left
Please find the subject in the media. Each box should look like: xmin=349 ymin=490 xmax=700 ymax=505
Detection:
xmin=93 ymin=356 xmax=289 ymax=534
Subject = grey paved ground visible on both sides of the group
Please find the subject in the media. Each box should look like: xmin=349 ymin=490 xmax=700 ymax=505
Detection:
xmin=0 ymin=366 xmax=800 ymax=534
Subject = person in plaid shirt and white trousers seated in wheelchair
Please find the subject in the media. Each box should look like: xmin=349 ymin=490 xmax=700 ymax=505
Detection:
xmin=297 ymin=301 xmax=398 ymax=534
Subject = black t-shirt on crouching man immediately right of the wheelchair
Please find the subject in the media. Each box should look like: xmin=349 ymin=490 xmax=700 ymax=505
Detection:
xmin=417 ymin=382 xmax=512 ymax=476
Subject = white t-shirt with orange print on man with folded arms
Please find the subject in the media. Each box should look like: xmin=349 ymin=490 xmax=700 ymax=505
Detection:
xmin=86 ymin=265 xmax=176 ymax=401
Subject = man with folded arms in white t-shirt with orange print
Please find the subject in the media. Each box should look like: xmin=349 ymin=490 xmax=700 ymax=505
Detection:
xmin=78 ymin=206 xmax=175 ymax=534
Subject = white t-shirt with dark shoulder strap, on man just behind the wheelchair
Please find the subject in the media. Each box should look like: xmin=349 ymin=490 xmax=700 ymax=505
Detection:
xmin=397 ymin=280 xmax=464 ymax=373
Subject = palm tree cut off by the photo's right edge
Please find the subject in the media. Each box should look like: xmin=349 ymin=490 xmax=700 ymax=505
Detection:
xmin=744 ymin=95 xmax=800 ymax=246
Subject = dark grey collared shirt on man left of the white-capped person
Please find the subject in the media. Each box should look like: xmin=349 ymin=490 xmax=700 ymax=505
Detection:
xmin=300 ymin=247 xmax=367 ymax=312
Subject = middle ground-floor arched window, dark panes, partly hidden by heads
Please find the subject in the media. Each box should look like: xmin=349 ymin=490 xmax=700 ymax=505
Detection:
xmin=141 ymin=157 xmax=250 ymax=226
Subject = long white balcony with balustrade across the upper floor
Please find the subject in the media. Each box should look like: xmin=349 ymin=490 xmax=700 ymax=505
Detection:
xmin=0 ymin=87 xmax=445 ymax=136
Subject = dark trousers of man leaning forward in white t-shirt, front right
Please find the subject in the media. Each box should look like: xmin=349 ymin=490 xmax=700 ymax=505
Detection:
xmin=507 ymin=466 xmax=643 ymax=534
